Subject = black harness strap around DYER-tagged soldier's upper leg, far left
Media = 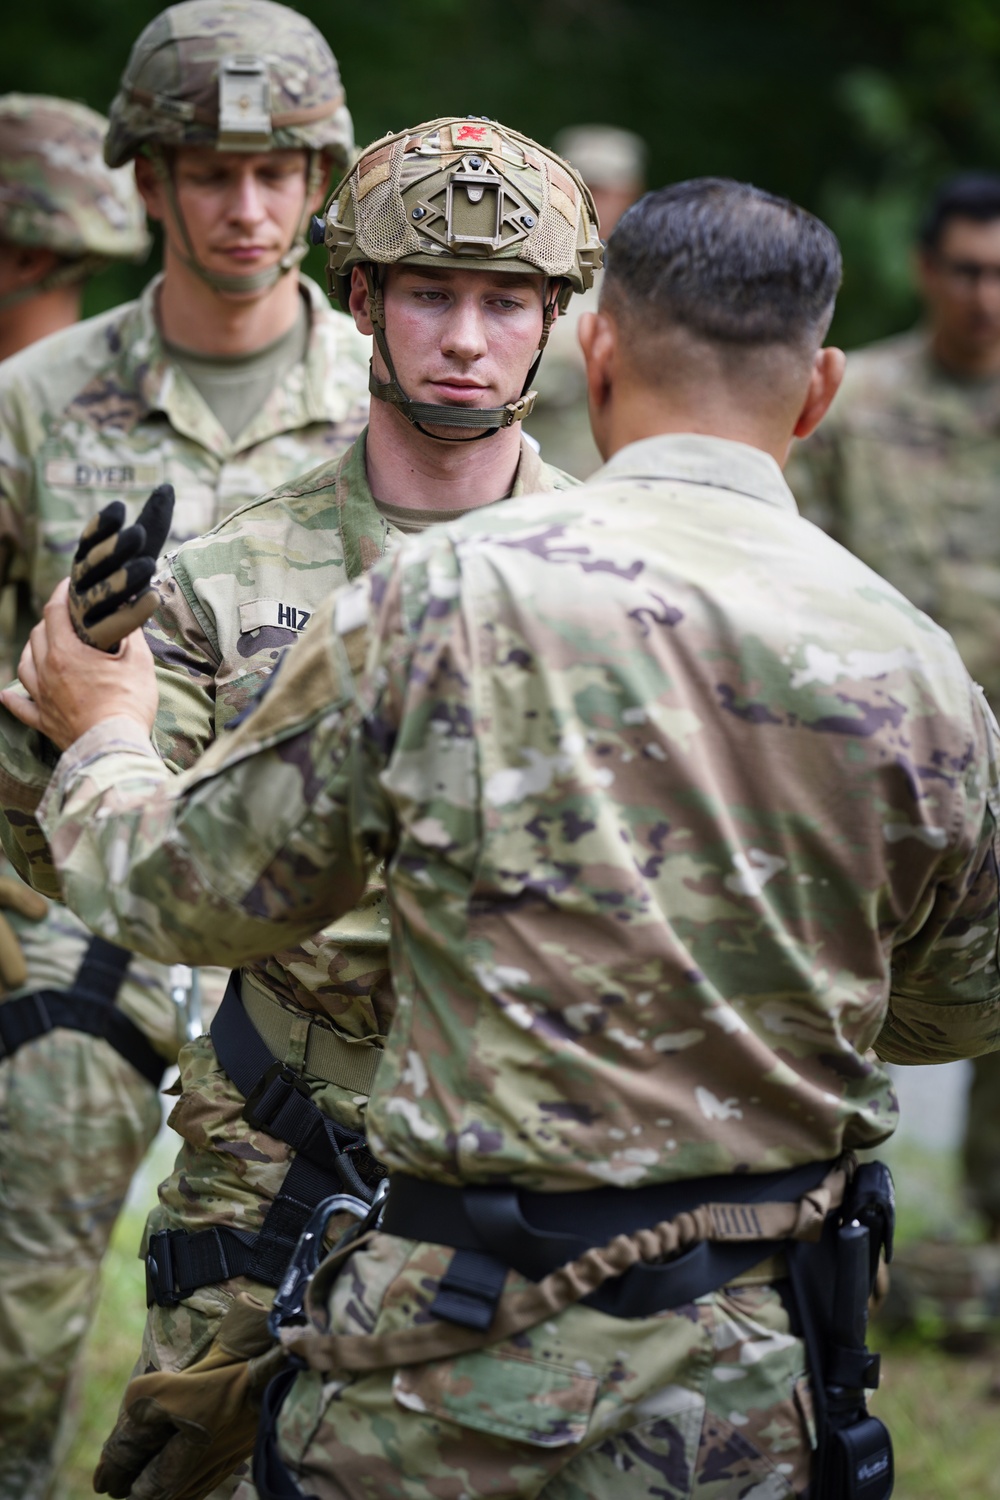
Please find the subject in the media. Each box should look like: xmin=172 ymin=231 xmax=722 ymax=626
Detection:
xmin=0 ymin=938 xmax=166 ymax=1089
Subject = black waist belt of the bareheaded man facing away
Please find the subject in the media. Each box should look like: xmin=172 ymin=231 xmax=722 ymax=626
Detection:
xmin=381 ymin=1161 xmax=835 ymax=1328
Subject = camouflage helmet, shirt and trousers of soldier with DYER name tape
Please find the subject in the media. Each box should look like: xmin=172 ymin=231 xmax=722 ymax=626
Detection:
xmin=0 ymin=0 xmax=369 ymax=1500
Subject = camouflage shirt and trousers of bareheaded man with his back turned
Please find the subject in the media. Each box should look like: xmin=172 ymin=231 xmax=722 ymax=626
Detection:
xmin=31 ymin=435 xmax=1000 ymax=1500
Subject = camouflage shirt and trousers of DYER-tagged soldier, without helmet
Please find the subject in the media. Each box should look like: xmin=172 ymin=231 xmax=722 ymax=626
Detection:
xmin=0 ymin=282 xmax=369 ymax=1500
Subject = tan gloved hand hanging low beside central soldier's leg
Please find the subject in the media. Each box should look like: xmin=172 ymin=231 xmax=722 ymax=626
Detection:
xmin=94 ymin=1293 xmax=285 ymax=1500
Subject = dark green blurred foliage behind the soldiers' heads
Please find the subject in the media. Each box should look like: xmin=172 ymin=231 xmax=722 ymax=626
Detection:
xmin=0 ymin=0 xmax=1000 ymax=347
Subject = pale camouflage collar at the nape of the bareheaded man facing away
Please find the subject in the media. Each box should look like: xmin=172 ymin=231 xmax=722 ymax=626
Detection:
xmin=588 ymin=432 xmax=798 ymax=510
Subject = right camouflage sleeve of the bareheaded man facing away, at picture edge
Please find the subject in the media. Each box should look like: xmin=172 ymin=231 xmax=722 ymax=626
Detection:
xmin=876 ymin=689 xmax=1000 ymax=1064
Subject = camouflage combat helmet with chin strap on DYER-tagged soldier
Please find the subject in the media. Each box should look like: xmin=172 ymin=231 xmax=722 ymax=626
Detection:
xmin=105 ymin=0 xmax=354 ymax=291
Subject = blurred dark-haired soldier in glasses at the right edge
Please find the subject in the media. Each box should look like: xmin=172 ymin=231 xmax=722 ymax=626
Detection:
xmin=789 ymin=174 xmax=1000 ymax=1266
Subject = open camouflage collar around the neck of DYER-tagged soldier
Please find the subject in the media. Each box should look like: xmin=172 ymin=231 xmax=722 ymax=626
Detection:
xmin=118 ymin=273 xmax=355 ymax=459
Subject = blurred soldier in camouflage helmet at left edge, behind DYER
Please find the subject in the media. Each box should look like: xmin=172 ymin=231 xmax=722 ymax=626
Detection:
xmin=0 ymin=93 xmax=150 ymax=360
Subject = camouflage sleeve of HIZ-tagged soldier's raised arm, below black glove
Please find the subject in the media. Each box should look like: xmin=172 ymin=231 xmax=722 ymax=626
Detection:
xmin=144 ymin=564 xmax=219 ymax=771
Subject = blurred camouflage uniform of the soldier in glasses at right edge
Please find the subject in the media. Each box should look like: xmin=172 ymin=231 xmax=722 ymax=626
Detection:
xmin=789 ymin=332 xmax=1000 ymax=1229
